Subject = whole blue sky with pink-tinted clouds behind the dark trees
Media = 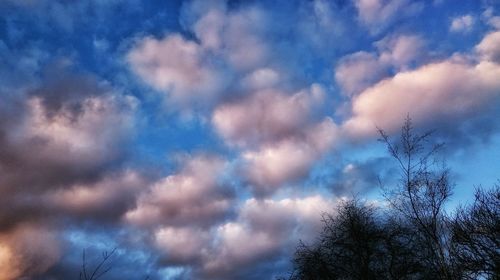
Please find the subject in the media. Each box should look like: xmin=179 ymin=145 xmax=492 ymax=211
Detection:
xmin=0 ymin=0 xmax=500 ymax=280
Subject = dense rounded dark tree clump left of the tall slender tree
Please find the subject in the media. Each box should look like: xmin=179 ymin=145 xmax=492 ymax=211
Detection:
xmin=290 ymin=200 xmax=430 ymax=279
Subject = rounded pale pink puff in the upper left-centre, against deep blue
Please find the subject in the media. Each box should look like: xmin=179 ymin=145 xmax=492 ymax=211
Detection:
xmin=127 ymin=34 xmax=224 ymax=105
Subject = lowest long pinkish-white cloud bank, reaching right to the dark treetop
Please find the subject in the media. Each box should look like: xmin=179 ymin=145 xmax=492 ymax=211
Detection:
xmin=155 ymin=196 xmax=332 ymax=279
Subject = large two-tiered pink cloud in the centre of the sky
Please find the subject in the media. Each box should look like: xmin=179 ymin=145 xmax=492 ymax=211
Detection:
xmin=212 ymin=85 xmax=337 ymax=194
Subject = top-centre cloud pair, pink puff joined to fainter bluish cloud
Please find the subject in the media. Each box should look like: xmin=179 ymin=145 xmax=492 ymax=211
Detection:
xmin=127 ymin=1 xmax=268 ymax=109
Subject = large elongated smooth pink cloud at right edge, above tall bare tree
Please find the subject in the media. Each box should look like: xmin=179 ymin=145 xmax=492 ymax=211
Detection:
xmin=343 ymin=32 xmax=500 ymax=137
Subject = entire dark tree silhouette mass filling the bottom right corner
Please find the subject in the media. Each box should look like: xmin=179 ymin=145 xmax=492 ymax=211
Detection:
xmin=289 ymin=117 xmax=500 ymax=280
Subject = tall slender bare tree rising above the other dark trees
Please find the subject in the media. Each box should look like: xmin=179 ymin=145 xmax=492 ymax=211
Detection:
xmin=379 ymin=117 xmax=457 ymax=279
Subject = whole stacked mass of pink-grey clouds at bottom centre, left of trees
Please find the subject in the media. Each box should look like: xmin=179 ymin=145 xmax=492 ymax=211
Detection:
xmin=123 ymin=155 xmax=332 ymax=279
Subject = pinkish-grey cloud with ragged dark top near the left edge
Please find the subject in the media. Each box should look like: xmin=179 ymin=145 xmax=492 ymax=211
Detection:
xmin=15 ymin=95 xmax=137 ymax=166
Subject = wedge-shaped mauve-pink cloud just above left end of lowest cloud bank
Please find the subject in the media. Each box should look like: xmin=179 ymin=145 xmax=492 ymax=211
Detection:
xmin=125 ymin=155 xmax=232 ymax=227
